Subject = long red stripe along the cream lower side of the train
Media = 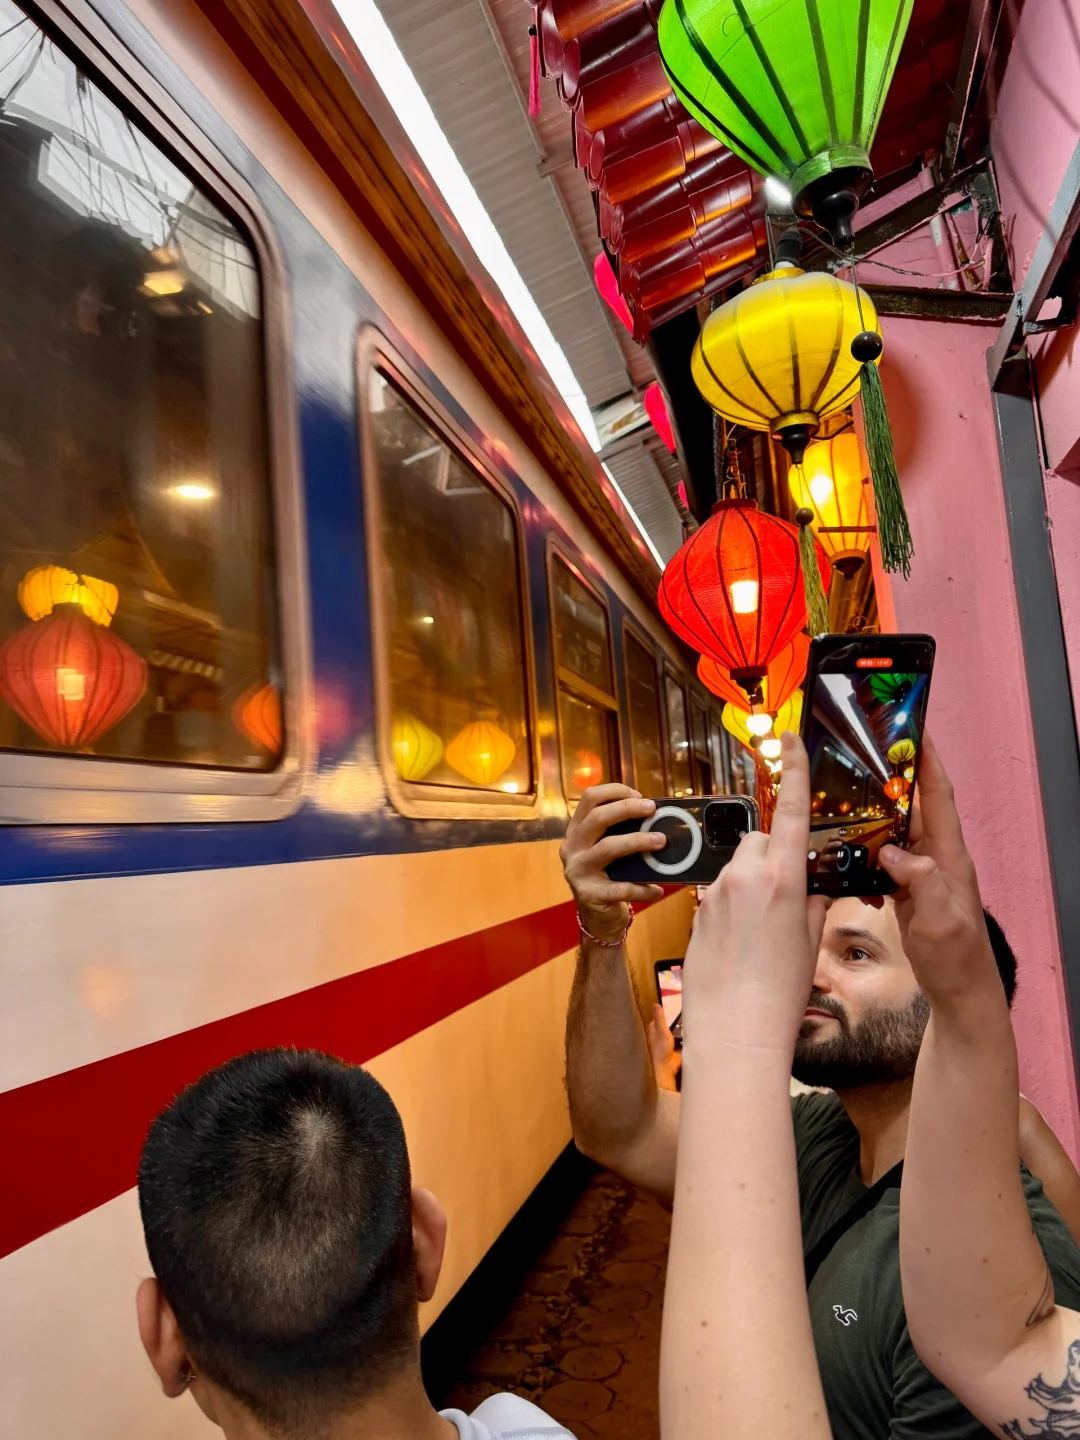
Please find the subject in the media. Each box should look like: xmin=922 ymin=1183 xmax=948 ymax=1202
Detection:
xmin=0 ymin=900 xmax=659 ymax=1256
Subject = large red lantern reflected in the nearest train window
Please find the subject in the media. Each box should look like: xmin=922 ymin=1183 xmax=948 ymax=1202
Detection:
xmin=0 ymin=605 xmax=147 ymax=750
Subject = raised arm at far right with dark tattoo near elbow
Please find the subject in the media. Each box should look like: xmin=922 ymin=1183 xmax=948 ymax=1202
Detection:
xmin=881 ymin=742 xmax=1080 ymax=1440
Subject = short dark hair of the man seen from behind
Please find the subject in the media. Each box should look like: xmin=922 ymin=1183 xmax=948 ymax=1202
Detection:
xmin=138 ymin=1050 xmax=419 ymax=1436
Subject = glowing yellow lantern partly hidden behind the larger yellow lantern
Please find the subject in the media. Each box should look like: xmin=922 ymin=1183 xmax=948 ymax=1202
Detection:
xmin=788 ymin=431 xmax=870 ymax=579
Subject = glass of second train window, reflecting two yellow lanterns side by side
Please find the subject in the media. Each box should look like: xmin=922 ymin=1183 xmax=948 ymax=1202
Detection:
xmin=367 ymin=370 xmax=533 ymax=795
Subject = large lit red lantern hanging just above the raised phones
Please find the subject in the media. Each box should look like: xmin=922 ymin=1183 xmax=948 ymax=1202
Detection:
xmin=658 ymin=500 xmax=832 ymax=696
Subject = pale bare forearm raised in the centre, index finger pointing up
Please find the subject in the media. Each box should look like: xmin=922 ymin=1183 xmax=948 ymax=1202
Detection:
xmin=660 ymin=734 xmax=829 ymax=1440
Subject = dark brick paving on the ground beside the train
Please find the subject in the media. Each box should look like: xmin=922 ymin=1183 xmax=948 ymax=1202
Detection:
xmin=445 ymin=1172 xmax=671 ymax=1440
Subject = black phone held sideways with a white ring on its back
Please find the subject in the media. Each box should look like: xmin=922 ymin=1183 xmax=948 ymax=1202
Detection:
xmin=606 ymin=795 xmax=760 ymax=886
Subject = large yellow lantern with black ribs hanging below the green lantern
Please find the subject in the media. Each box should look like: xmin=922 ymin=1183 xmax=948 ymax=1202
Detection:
xmin=690 ymin=264 xmax=880 ymax=464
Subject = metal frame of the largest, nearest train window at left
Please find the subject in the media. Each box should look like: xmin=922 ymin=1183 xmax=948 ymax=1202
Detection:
xmin=0 ymin=0 xmax=314 ymax=825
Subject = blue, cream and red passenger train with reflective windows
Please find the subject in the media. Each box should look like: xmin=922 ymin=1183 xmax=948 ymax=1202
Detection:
xmin=0 ymin=0 xmax=753 ymax=1440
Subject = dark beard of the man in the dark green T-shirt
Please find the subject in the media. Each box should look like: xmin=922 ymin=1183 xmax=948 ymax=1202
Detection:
xmin=792 ymin=991 xmax=930 ymax=1090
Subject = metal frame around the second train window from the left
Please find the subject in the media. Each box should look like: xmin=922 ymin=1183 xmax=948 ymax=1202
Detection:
xmin=356 ymin=325 xmax=540 ymax=819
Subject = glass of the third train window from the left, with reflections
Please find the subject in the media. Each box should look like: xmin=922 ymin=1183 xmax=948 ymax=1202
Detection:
xmin=552 ymin=554 xmax=618 ymax=801
